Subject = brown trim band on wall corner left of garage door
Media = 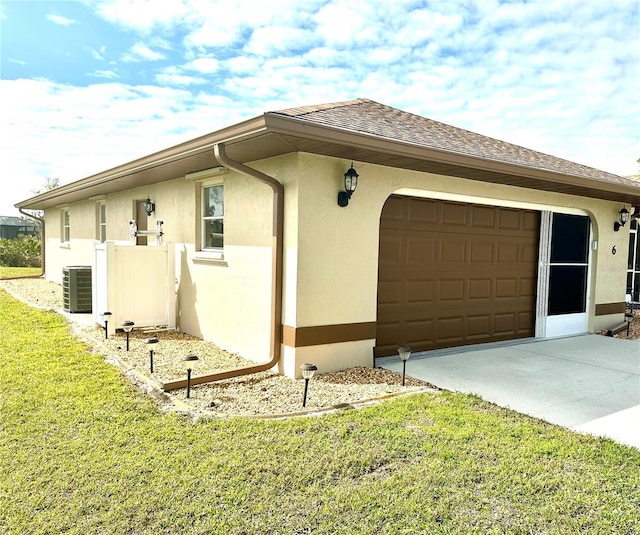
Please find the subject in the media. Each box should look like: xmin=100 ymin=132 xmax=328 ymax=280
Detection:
xmin=282 ymin=321 xmax=376 ymax=347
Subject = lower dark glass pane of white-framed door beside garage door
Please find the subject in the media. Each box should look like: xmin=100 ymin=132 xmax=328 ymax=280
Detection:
xmin=549 ymin=266 xmax=587 ymax=316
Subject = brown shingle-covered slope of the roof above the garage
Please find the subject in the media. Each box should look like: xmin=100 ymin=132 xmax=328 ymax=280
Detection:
xmin=273 ymin=98 xmax=633 ymax=188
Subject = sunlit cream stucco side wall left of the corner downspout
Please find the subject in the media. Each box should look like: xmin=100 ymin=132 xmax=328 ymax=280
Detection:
xmin=46 ymin=162 xmax=277 ymax=361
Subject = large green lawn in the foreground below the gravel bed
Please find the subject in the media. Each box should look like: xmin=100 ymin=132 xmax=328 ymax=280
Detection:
xmin=0 ymin=291 xmax=640 ymax=535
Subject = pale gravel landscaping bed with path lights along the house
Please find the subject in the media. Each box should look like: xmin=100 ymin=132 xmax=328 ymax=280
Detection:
xmin=0 ymin=278 xmax=435 ymax=416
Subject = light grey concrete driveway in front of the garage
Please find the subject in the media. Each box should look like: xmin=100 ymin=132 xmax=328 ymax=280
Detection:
xmin=376 ymin=335 xmax=640 ymax=449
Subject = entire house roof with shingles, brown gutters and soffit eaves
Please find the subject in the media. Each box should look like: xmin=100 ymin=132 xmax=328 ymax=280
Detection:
xmin=16 ymin=99 xmax=640 ymax=209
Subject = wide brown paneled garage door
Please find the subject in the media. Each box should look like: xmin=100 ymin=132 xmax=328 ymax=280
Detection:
xmin=375 ymin=196 xmax=540 ymax=356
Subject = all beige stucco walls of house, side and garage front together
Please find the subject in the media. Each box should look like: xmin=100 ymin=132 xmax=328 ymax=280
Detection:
xmin=46 ymin=149 xmax=628 ymax=376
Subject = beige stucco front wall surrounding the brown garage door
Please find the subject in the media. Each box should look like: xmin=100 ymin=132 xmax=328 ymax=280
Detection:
xmin=287 ymin=154 xmax=628 ymax=369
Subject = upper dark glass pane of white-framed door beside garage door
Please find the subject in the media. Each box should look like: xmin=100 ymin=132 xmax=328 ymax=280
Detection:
xmin=551 ymin=214 xmax=590 ymax=264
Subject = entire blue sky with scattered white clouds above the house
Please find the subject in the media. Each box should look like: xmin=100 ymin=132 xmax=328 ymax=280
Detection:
xmin=0 ymin=0 xmax=640 ymax=215
